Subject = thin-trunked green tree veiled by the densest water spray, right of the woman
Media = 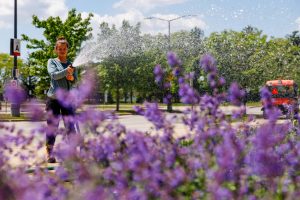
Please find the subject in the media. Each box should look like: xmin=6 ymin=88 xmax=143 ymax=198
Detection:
xmin=95 ymin=21 xmax=142 ymax=111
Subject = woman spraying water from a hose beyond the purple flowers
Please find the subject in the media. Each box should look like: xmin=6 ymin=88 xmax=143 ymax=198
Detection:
xmin=46 ymin=37 xmax=77 ymax=163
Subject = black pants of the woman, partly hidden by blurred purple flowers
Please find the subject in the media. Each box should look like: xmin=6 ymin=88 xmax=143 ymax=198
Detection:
xmin=46 ymin=99 xmax=76 ymax=146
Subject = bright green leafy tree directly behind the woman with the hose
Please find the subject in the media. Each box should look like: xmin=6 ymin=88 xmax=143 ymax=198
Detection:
xmin=22 ymin=9 xmax=93 ymax=97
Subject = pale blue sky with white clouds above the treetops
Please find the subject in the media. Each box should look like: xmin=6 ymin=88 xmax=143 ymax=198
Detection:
xmin=0 ymin=0 xmax=300 ymax=58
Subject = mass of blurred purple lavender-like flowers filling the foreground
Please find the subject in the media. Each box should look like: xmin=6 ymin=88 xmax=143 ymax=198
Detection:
xmin=0 ymin=53 xmax=300 ymax=199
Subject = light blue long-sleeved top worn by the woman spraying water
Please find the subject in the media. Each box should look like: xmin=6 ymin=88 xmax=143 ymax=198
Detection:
xmin=47 ymin=58 xmax=77 ymax=98
